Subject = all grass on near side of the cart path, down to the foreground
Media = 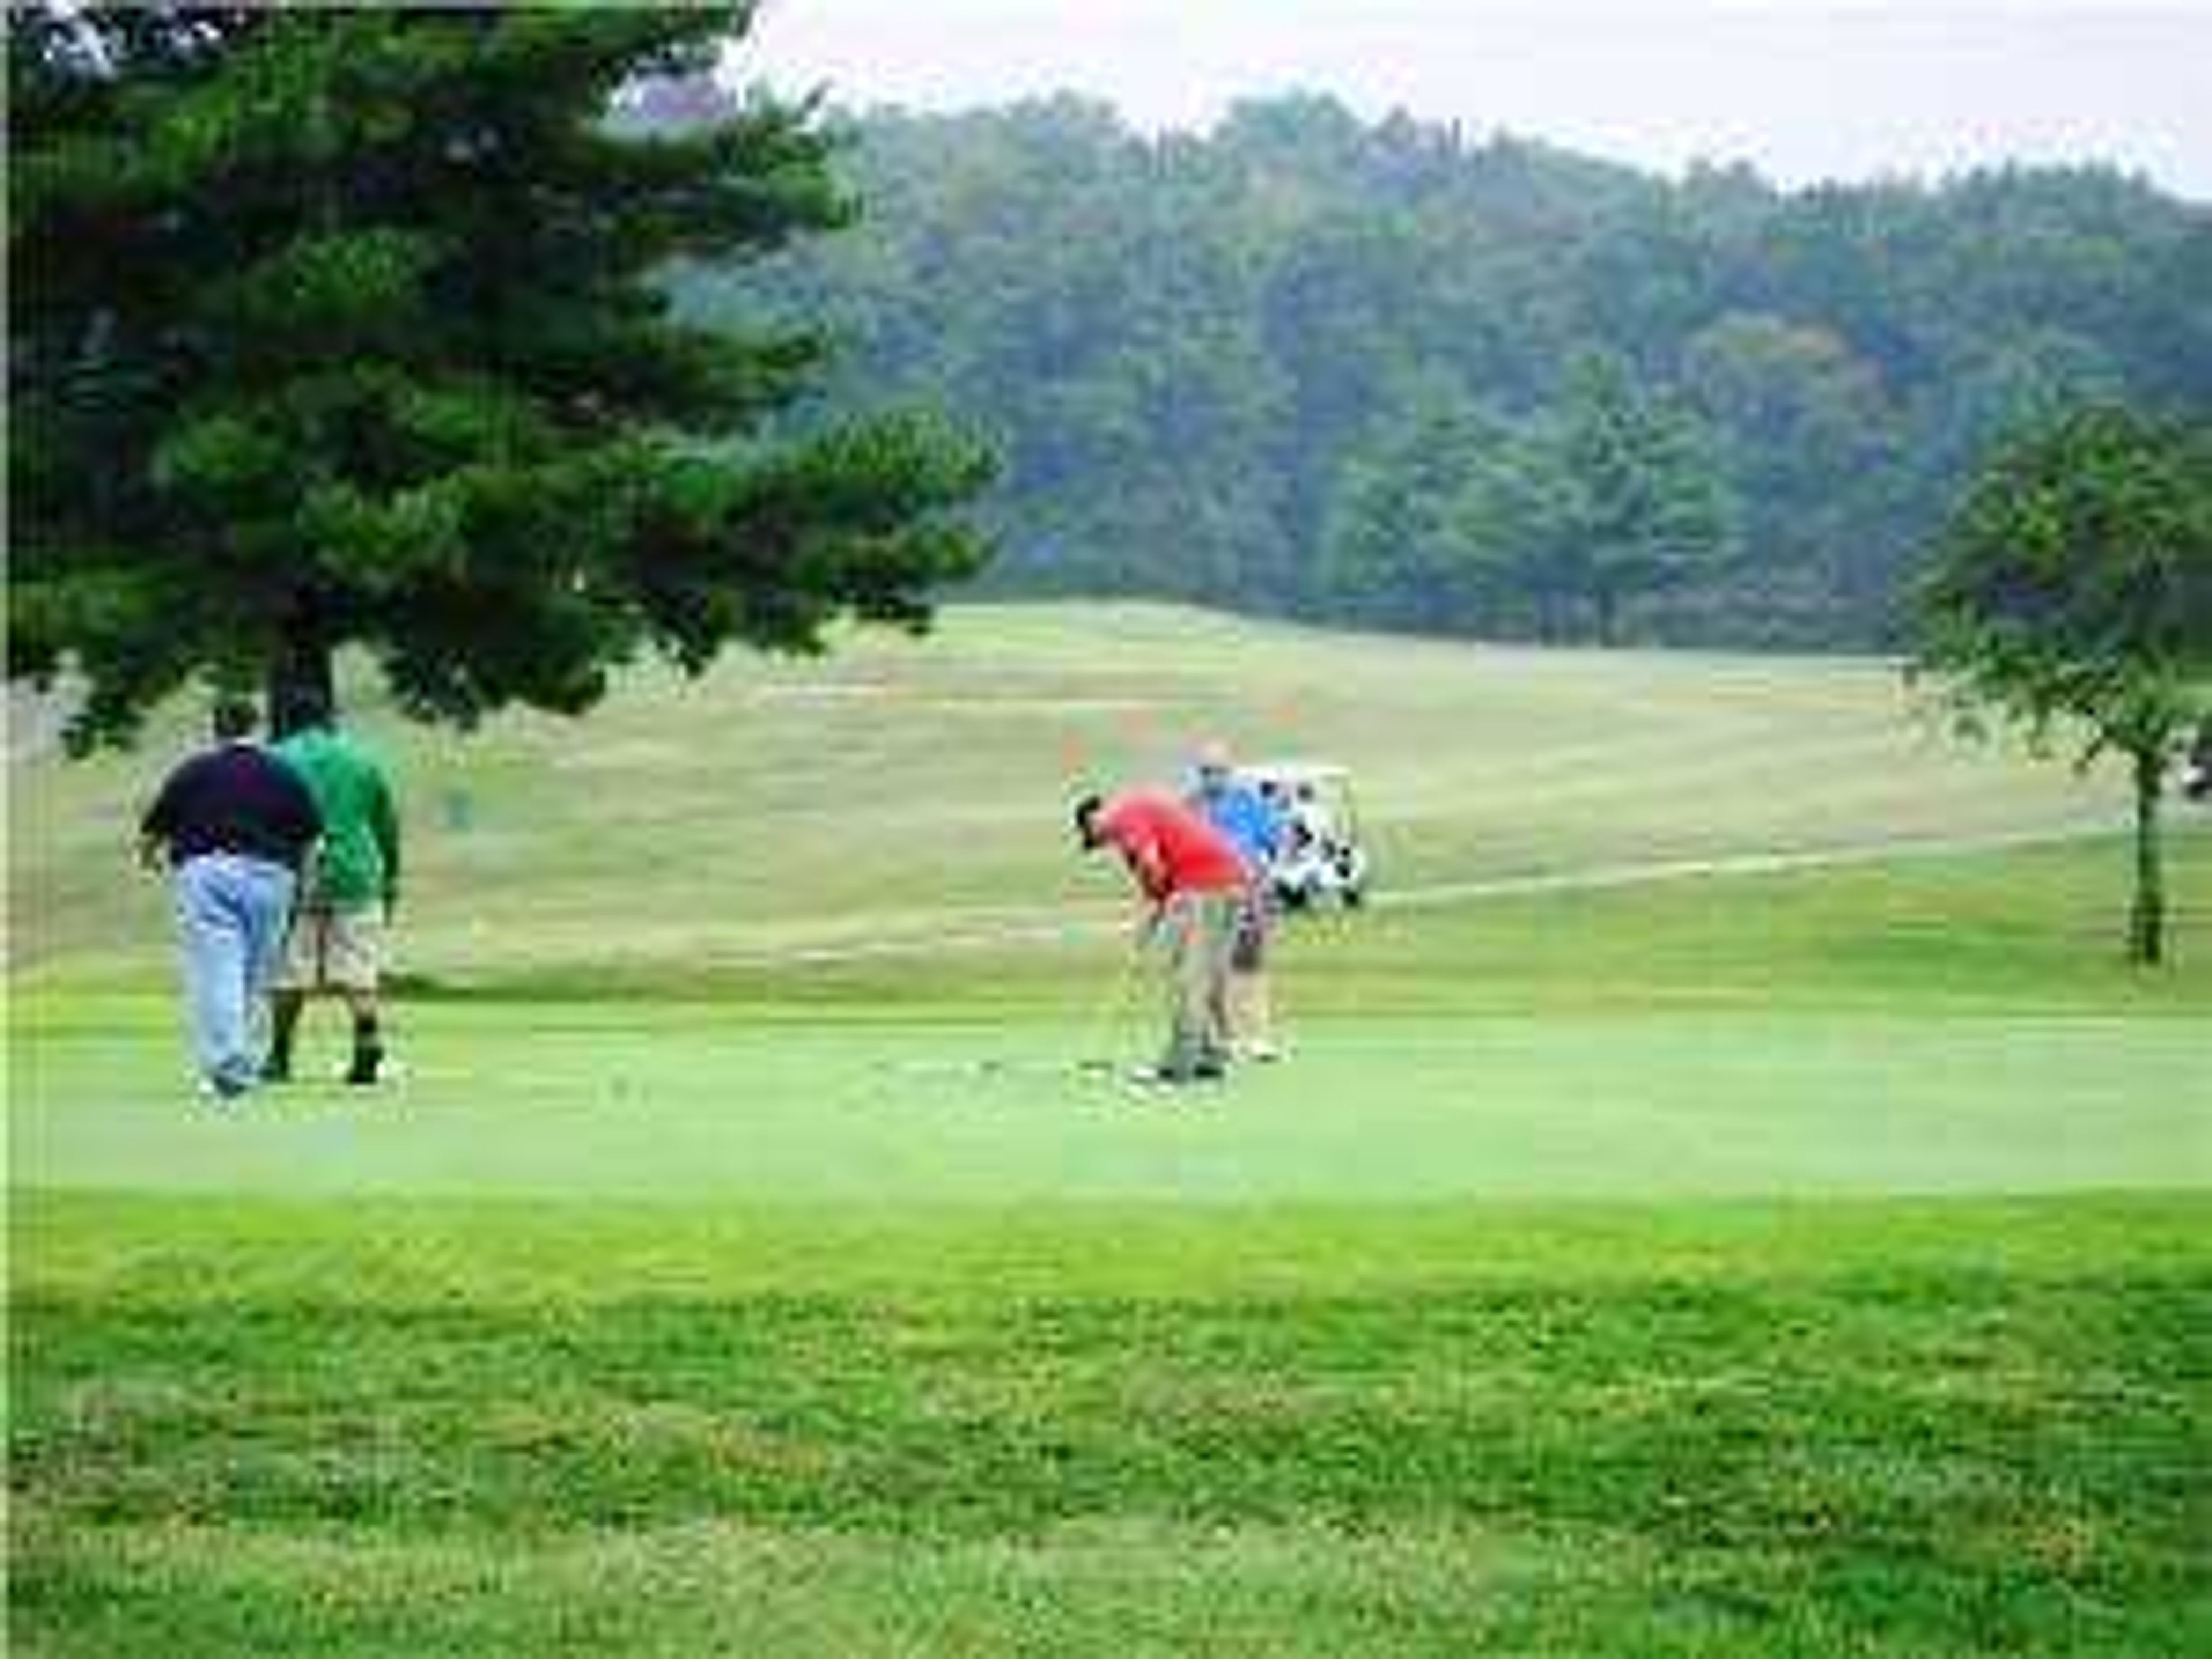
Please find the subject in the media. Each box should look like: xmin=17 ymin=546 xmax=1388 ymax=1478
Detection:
xmin=13 ymin=843 xmax=2212 ymax=1659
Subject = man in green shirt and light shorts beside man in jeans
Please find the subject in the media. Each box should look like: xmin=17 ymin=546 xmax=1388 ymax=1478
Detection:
xmin=266 ymin=692 xmax=400 ymax=1084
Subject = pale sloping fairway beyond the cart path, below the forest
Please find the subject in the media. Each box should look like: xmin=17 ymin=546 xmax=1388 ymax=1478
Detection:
xmin=9 ymin=604 xmax=2123 ymax=980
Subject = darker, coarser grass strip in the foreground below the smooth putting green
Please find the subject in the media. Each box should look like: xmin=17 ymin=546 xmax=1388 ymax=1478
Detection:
xmin=13 ymin=1196 xmax=2212 ymax=1659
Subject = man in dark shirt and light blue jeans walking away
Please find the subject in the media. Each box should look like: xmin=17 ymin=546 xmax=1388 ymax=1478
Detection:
xmin=139 ymin=697 xmax=323 ymax=1099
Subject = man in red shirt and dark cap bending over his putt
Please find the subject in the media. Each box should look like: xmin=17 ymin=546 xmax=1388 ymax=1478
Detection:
xmin=1075 ymin=794 xmax=1250 ymax=1084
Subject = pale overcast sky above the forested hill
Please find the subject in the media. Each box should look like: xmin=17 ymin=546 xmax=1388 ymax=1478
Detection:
xmin=737 ymin=0 xmax=2212 ymax=201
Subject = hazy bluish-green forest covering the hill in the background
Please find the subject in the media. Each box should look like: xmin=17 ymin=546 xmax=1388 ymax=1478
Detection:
xmin=677 ymin=95 xmax=2212 ymax=648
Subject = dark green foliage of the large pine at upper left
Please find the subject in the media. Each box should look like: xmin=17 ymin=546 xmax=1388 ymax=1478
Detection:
xmin=9 ymin=7 xmax=987 ymax=745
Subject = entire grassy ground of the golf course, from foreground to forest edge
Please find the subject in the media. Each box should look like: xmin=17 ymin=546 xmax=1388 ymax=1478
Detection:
xmin=9 ymin=611 xmax=2212 ymax=1659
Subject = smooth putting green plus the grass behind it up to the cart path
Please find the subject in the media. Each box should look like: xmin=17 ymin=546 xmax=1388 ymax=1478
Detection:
xmin=13 ymin=836 xmax=2212 ymax=1203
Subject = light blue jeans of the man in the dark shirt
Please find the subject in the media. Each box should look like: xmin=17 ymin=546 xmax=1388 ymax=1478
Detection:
xmin=175 ymin=851 xmax=292 ymax=1095
